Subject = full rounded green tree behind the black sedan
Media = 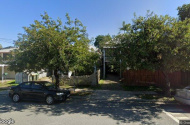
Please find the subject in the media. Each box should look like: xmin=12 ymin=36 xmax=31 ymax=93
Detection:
xmin=9 ymin=13 xmax=96 ymax=88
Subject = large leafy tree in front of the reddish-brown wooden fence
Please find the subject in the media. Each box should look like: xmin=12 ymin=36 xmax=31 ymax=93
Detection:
xmin=118 ymin=13 xmax=190 ymax=95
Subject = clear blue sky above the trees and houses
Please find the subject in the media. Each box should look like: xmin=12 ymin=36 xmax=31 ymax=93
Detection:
xmin=0 ymin=0 xmax=190 ymax=47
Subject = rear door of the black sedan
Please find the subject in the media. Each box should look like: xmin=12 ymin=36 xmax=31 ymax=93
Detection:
xmin=20 ymin=82 xmax=32 ymax=99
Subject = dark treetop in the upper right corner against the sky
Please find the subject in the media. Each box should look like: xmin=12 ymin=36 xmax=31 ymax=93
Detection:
xmin=177 ymin=4 xmax=190 ymax=21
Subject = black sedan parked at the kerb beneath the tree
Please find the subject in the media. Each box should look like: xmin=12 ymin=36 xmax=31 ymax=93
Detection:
xmin=9 ymin=81 xmax=70 ymax=105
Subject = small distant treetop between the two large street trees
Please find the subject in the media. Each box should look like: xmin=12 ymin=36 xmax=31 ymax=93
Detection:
xmin=94 ymin=34 xmax=112 ymax=49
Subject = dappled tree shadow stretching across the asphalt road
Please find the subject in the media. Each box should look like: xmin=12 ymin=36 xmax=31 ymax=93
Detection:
xmin=0 ymin=95 xmax=166 ymax=125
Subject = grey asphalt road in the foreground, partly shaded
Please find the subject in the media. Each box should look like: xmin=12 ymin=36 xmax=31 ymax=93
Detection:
xmin=0 ymin=91 xmax=178 ymax=125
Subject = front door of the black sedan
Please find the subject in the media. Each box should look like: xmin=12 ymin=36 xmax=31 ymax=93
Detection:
xmin=32 ymin=82 xmax=45 ymax=100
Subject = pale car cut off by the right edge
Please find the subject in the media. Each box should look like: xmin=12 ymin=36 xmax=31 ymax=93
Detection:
xmin=174 ymin=86 xmax=190 ymax=105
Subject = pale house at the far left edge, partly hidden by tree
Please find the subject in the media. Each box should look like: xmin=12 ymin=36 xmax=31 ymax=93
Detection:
xmin=0 ymin=46 xmax=17 ymax=81
